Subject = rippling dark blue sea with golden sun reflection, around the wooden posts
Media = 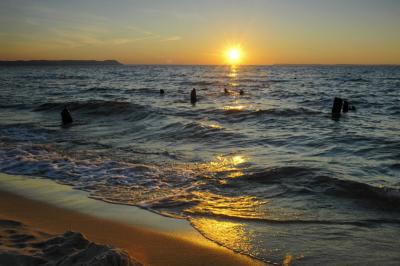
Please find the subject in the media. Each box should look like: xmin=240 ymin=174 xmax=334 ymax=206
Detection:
xmin=0 ymin=65 xmax=400 ymax=265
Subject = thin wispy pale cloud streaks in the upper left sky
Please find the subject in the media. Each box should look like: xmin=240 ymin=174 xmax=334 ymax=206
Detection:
xmin=0 ymin=3 xmax=182 ymax=49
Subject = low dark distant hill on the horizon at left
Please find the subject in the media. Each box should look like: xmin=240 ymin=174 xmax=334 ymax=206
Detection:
xmin=0 ymin=60 xmax=122 ymax=66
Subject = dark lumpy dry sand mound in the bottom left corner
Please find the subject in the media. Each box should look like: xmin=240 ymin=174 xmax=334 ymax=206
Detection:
xmin=0 ymin=219 xmax=142 ymax=266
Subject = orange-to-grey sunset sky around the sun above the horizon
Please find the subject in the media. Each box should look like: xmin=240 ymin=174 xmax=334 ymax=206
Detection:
xmin=0 ymin=0 xmax=400 ymax=65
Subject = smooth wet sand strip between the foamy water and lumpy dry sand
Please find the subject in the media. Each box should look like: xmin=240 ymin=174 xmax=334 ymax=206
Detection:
xmin=0 ymin=173 xmax=265 ymax=265
